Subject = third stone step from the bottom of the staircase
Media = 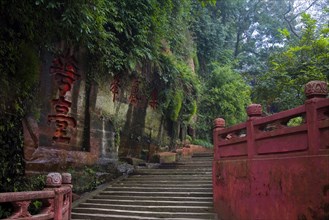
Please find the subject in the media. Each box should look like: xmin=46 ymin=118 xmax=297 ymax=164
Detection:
xmin=93 ymin=194 xmax=213 ymax=202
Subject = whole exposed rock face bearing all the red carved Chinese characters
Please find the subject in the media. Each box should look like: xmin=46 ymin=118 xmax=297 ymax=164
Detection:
xmin=23 ymin=51 xmax=169 ymax=173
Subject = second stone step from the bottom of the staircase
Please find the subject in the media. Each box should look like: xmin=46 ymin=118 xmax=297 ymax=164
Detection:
xmin=78 ymin=203 xmax=213 ymax=213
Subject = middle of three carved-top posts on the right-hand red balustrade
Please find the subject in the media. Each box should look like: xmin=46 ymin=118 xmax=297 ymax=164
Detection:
xmin=247 ymin=104 xmax=262 ymax=159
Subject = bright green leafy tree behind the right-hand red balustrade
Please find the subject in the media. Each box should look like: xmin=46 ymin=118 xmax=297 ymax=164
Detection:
xmin=254 ymin=14 xmax=329 ymax=112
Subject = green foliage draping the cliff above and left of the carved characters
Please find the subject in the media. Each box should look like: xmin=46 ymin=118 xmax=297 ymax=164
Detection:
xmin=0 ymin=0 xmax=199 ymax=191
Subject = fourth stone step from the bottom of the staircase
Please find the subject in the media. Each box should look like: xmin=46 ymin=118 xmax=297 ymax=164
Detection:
xmin=104 ymin=186 xmax=212 ymax=193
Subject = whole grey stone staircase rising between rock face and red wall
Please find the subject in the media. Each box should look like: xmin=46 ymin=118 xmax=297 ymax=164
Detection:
xmin=72 ymin=153 xmax=217 ymax=220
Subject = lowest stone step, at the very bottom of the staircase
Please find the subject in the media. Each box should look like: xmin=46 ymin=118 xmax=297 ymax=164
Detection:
xmin=72 ymin=207 xmax=215 ymax=219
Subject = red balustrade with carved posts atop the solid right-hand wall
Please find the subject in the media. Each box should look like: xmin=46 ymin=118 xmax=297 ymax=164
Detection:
xmin=214 ymin=83 xmax=329 ymax=160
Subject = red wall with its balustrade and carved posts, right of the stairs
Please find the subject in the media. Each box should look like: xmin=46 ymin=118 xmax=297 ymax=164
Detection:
xmin=213 ymin=81 xmax=329 ymax=219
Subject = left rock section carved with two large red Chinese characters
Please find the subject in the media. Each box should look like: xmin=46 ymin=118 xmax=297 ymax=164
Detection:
xmin=23 ymin=49 xmax=99 ymax=173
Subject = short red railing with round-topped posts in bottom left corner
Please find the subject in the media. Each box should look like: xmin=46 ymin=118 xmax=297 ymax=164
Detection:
xmin=0 ymin=173 xmax=72 ymax=220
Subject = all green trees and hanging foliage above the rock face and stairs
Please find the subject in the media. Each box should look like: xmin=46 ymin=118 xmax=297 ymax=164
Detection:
xmin=0 ymin=0 xmax=329 ymax=191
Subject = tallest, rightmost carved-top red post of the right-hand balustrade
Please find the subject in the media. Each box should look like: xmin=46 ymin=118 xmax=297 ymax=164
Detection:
xmin=305 ymin=81 xmax=328 ymax=155
